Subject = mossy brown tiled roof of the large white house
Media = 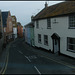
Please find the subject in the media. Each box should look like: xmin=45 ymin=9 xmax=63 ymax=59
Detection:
xmin=34 ymin=1 xmax=75 ymax=20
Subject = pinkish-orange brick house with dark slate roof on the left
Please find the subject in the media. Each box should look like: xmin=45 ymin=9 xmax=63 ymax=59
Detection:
xmin=2 ymin=11 xmax=13 ymax=43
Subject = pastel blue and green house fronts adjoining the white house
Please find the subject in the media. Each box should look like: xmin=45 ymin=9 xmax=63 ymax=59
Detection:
xmin=24 ymin=22 xmax=34 ymax=46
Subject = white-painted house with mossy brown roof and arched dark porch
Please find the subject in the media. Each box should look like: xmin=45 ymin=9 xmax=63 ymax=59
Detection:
xmin=34 ymin=1 xmax=75 ymax=58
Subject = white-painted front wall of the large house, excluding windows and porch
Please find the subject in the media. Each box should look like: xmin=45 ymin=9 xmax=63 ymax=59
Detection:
xmin=34 ymin=16 xmax=75 ymax=57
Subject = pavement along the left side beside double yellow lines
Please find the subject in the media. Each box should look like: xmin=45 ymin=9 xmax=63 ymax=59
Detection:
xmin=0 ymin=42 xmax=13 ymax=74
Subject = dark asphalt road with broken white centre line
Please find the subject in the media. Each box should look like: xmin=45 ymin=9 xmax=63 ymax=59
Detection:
xmin=4 ymin=39 xmax=75 ymax=74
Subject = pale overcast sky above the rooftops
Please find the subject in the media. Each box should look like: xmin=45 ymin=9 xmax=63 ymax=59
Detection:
xmin=0 ymin=1 xmax=62 ymax=26
